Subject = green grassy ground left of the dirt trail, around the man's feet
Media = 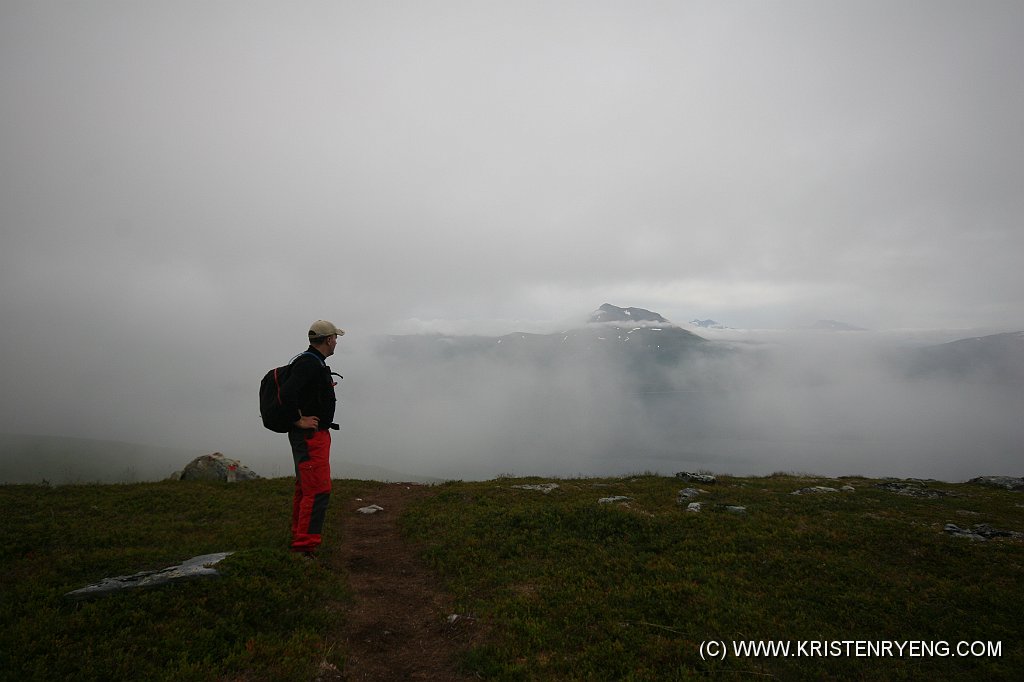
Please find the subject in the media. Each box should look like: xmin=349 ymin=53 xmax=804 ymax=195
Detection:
xmin=0 ymin=478 xmax=365 ymax=680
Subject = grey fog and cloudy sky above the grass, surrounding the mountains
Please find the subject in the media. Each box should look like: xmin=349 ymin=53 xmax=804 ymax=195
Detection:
xmin=0 ymin=0 xmax=1024 ymax=477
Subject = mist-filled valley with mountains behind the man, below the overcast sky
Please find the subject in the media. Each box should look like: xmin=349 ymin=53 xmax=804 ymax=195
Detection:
xmin=0 ymin=304 xmax=1024 ymax=482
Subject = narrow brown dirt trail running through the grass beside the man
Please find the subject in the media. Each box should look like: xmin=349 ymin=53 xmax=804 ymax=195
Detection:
xmin=333 ymin=483 xmax=478 ymax=682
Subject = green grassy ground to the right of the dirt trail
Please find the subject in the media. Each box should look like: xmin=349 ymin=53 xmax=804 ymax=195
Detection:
xmin=404 ymin=476 xmax=1024 ymax=680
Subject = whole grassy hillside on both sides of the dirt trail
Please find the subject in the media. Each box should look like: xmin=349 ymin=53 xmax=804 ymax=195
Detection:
xmin=0 ymin=476 xmax=1024 ymax=680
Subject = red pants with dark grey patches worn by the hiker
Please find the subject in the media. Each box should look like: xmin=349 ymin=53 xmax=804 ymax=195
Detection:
xmin=288 ymin=431 xmax=331 ymax=552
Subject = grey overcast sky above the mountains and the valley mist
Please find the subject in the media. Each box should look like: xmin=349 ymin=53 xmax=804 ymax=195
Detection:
xmin=0 ymin=0 xmax=1024 ymax=477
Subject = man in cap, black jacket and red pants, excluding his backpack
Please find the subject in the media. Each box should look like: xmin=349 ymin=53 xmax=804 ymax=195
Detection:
xmin=281 ymin=319 xmax=345 ymax=558
